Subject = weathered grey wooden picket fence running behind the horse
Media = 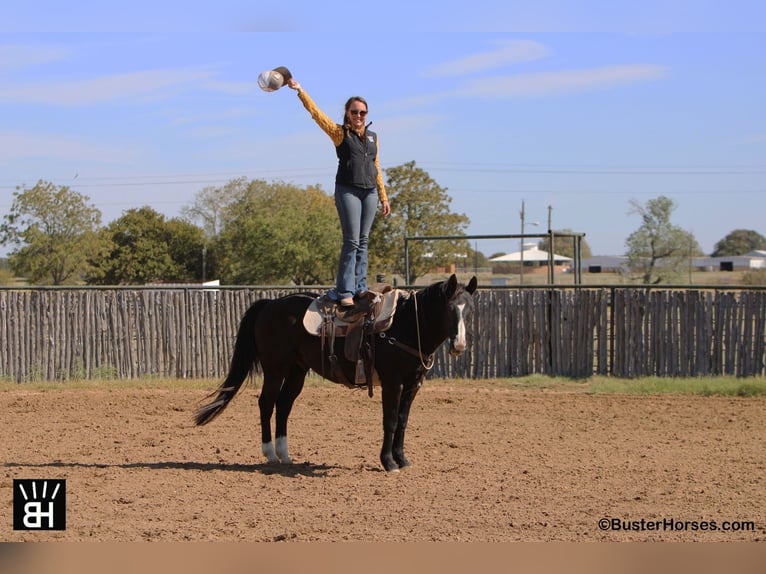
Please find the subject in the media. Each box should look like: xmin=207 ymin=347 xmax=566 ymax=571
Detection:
xmin=0 ymin=287 xmax=766 ymax=382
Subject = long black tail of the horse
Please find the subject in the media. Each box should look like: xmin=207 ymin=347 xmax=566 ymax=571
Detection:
xmin=194 ymin=299 xmax=270 ymax=425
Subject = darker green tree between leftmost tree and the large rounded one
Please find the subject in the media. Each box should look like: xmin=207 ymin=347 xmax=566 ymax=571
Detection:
xmin=88 ymin=206 xmax=204 ymax=285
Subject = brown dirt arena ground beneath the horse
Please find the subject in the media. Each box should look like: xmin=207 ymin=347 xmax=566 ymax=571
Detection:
xmin=0 ymin=381 xmax=766 ymax=542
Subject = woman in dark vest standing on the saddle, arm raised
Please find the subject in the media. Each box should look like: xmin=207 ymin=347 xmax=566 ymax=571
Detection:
xmin=287 ymin=78 xmax=391 ymax=308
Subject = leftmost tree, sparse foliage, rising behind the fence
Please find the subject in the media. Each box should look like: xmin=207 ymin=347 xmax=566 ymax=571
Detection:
xmin=0 ymin=180 xmax=101 ymax=285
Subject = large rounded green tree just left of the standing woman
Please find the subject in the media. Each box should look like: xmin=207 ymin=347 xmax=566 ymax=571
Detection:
xmin=216 ymin=180 xmax=341 ymax=285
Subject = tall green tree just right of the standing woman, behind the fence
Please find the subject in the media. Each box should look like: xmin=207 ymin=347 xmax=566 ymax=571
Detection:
xmin=370 ymin=161 xmax=470 ymax=283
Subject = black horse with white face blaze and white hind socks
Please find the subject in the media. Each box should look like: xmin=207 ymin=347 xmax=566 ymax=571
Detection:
xmin=195 ymin=275 xmax=476 ymax=471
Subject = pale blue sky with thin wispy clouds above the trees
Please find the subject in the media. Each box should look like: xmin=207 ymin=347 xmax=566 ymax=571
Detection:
xmin=0 ymin=0 xmax=766 ymax=255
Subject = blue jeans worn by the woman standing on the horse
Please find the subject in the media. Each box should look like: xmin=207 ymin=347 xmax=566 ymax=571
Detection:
xmin=329 ymin=184 xmax=378 ymax=299
